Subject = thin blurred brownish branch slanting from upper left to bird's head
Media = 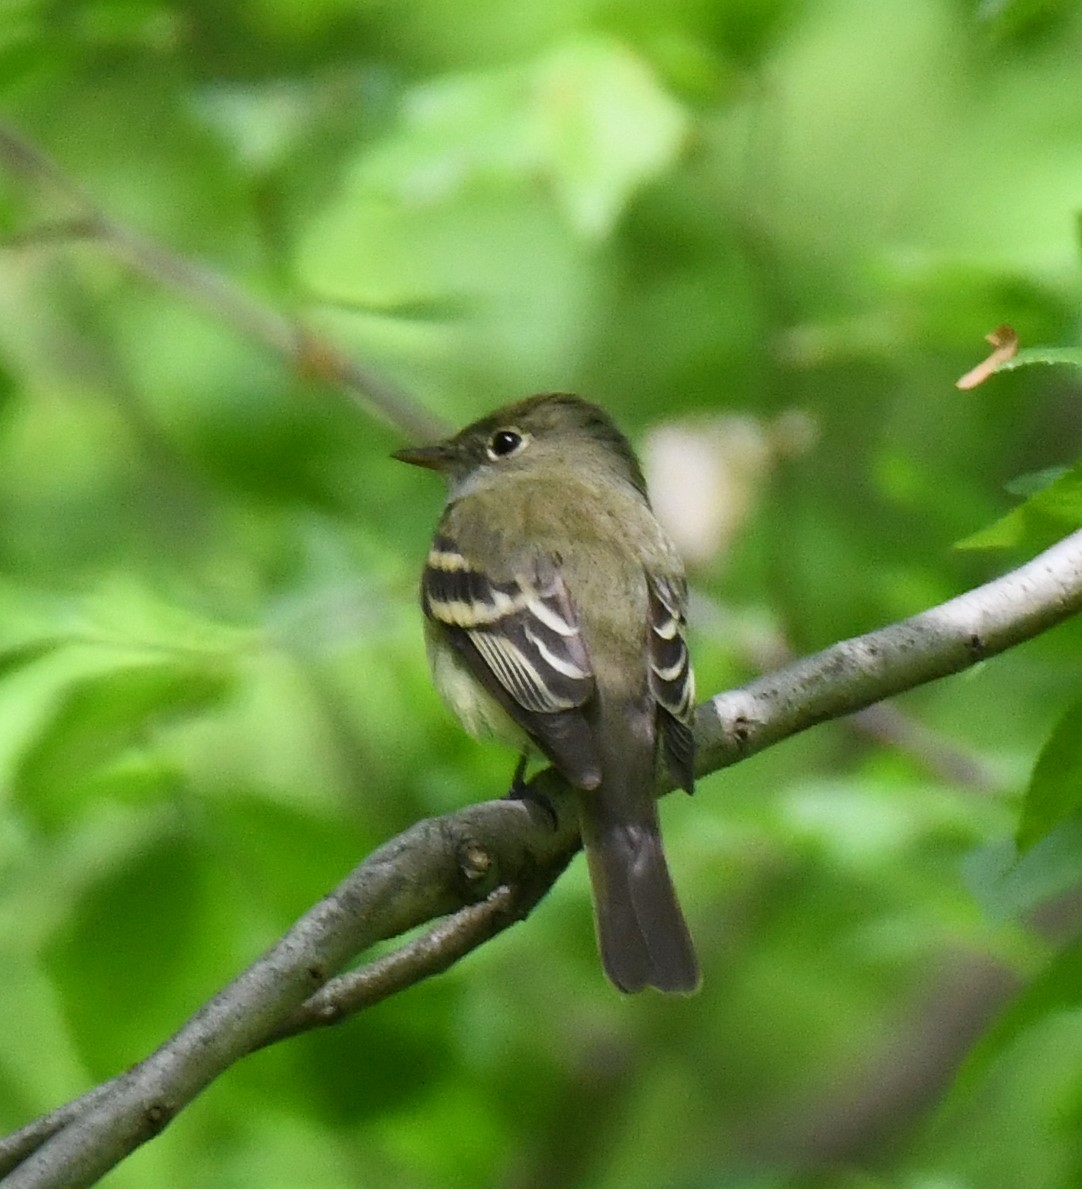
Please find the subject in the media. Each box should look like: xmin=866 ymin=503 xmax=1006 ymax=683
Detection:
xmin=0 ymin=124 xmax=448 ymax=441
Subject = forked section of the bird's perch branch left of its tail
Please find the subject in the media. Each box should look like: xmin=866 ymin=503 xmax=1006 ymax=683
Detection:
xmin=0 ymin=789 xmax=578 ymax=1189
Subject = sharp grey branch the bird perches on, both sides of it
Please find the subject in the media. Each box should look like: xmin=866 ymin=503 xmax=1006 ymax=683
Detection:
xmin=0 ymin=531 xmax=1082 ymax=1189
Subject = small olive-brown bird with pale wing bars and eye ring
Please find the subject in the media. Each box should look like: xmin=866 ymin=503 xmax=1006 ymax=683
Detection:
xmin=395 ymin=392 xmax=699 ymax=993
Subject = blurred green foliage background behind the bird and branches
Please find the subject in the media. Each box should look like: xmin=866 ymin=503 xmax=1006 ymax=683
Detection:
xmin=0 ymin=0 xmax=1082 ymax=1189
